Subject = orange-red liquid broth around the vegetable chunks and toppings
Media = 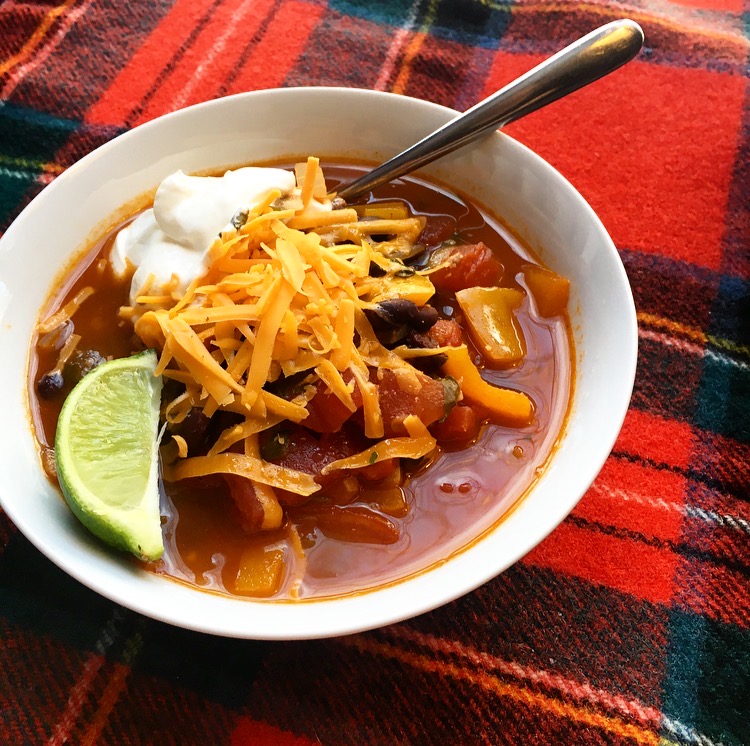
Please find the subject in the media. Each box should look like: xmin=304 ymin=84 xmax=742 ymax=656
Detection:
xmin=29 ymin=163 xmax=573 ymax=599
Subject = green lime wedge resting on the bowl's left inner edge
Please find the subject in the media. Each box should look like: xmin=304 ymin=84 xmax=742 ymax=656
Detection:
xmin=55 ymin=350 xmax=164 ymax=560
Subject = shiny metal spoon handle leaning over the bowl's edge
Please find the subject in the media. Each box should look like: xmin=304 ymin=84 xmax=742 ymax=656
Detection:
xmin=338 ymin=19 xmax=643 ymax=200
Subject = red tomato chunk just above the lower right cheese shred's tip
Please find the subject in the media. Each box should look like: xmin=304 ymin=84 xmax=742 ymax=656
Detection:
xmin=373 ymin=369 xmax=445 ymax=437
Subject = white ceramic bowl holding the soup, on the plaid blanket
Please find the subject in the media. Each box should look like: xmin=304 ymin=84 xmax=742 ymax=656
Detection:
xmin=0 ymin=88 xmax=637 ymax=639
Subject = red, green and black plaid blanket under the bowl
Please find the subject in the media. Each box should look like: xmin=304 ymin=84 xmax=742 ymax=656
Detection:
xmin=0 ymin=0 xmax=750 ymax=746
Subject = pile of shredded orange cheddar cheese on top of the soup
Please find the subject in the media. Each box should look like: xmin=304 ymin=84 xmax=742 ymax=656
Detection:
xmin=123 ymin=158 xmax=436 ymax=512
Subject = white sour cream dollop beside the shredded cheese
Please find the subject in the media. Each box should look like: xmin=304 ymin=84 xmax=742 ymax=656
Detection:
xmin=110 ymin=167 xmax=295 ymax=305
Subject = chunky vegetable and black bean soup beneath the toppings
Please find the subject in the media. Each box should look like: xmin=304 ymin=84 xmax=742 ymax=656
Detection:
xmin=30 ymin=158 xmax=573 ymax=599
